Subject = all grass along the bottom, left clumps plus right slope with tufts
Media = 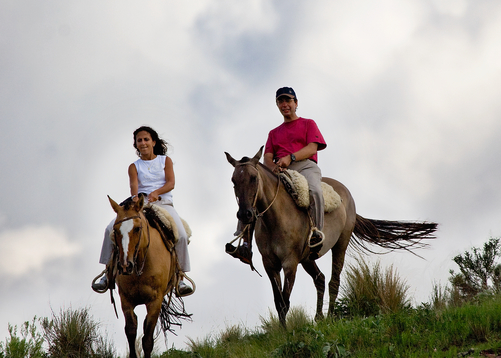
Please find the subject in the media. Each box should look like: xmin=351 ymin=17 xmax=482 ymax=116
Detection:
xmin=0 ymin=261 xmax=501 ymax=358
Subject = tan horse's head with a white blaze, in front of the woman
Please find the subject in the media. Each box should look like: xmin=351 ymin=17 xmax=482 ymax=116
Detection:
xmin=108 ymin=195 xmax=147 ymax=275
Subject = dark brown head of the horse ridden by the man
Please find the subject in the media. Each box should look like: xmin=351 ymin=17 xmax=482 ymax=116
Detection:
xmin=225 ymin=147 xmax=263 ymax=224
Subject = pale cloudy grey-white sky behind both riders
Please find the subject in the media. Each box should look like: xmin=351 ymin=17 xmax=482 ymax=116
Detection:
xmin=0 ymin=0 xmax=501 ymax=352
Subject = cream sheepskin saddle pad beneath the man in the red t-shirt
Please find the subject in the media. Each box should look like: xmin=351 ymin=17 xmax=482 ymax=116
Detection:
xmin=278 ymin=169 xmax=342 ymax=213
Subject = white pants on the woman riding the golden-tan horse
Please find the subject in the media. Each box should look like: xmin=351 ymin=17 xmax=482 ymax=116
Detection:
xmin=99 ymin=204 xmax=191 ymax=272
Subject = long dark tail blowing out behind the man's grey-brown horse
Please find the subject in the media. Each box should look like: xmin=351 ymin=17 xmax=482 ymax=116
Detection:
xmin=352 ymin=214 xmax=438 ymax=256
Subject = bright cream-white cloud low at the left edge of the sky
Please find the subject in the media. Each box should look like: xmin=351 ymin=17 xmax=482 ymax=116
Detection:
xmin=0 ymin=225 xmax=80 ymax=276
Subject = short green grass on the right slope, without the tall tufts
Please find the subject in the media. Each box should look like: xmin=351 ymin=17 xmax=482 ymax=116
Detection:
xmin=161 ymin=296 xmax=501 ymax=358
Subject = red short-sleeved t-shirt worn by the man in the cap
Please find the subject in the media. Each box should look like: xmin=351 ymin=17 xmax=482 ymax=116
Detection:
xmin=264 ymin=117 xmax=327 ymax=163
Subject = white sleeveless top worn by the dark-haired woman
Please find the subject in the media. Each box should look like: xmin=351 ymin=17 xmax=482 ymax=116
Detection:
xmin=134 ymin=155 xmax=173 ymax=204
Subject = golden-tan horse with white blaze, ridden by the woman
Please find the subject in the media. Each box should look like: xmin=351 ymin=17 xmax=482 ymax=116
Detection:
xmin=108 ymin=196 xmax=189 ymax=358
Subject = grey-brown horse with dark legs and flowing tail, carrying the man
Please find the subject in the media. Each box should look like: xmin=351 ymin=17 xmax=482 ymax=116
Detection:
xmin=225 ymin=147 xmax=437 ymax=326
